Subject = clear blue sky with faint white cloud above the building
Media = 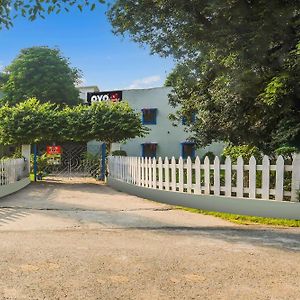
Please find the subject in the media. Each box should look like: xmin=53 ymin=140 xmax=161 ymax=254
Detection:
xmin=0 ymin=5 xmax=174 ymax=90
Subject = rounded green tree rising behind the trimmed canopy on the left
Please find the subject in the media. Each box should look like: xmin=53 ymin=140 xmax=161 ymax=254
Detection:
xmin=0 ymin=47 xmax=80 ymax=105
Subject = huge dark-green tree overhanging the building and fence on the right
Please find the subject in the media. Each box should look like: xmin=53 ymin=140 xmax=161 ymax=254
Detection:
xmin=109 ymin=0 xmax=300 ymax=152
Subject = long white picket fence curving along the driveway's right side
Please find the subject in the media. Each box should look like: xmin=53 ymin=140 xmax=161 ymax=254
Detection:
xmin=109 ymin=155 xmax=300 ymax=202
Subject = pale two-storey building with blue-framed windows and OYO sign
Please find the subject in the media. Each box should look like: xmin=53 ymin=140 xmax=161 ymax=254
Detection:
xmin=80 ymin=86 xmax=224 ymax=158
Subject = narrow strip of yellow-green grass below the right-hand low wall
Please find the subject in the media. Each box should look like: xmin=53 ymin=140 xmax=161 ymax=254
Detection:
xmin=177 ymin=206 xmax=300 ymax=227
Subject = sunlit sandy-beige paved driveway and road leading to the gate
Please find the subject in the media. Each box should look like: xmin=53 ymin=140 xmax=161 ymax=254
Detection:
xmin=0 ymin=181 xmax=300 ymax=300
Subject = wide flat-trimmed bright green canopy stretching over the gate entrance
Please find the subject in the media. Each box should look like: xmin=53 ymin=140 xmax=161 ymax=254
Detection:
xmin=0 ymin=99 xmax=148 ymax=145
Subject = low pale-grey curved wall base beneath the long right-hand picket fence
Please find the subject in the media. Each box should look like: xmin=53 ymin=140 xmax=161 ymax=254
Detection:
xmin=107 ymin=177 xmax=300 ymax=220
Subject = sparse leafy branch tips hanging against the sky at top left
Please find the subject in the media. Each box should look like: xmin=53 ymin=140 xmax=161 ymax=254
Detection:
xmin=0 ymin=0 xmax=104 ymax=30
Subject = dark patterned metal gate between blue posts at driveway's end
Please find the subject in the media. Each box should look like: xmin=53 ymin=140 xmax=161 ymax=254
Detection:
xmin=37 ymin=143 xmax=105 ymax=179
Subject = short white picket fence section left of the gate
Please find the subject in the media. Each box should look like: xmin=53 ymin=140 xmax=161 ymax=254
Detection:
xmin=0 ymin=158 xmax=29 ymax=186
